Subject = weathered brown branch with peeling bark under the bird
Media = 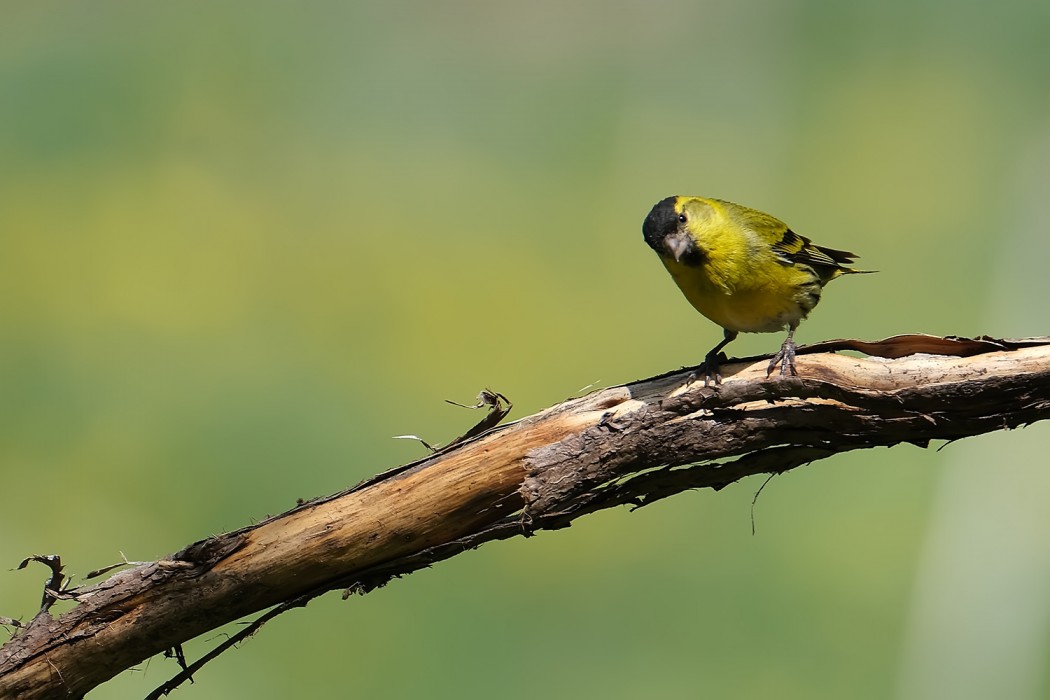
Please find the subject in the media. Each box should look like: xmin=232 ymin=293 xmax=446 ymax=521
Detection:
xmin=0 ymin=336 xmax=1050 ymax=699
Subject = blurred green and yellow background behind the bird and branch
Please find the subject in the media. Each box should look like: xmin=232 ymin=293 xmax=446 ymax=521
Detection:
xmin=0 ymin=0 xmax=1050 ymax=700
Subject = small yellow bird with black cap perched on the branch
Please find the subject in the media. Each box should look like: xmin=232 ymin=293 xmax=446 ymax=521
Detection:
xmin=642 ymin=196 xmax=874 ymax=386
